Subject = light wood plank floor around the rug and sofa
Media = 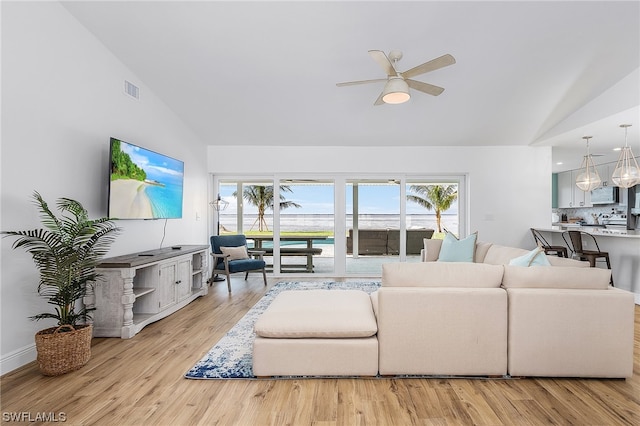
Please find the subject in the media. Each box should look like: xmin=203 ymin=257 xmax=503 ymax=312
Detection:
xmin=0 ymin=276 xmax=640 ymax=425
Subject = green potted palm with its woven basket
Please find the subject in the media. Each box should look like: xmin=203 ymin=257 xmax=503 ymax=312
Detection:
xmin=2 ymin=192 xmax=119 ymax=376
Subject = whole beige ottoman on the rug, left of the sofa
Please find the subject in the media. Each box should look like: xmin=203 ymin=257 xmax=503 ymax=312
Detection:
xmin=253 ymin=290 xmax=378 ymax=376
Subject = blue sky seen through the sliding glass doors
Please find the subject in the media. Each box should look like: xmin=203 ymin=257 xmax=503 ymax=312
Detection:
xmin=220 ymin=184 xmax=458 ymax=214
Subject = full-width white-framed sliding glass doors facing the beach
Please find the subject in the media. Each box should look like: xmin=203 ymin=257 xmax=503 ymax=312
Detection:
xmin=210 ymin=175 xmax=466 ymax=277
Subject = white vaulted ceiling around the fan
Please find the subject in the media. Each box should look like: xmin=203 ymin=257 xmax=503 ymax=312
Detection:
xmin=58 ymin=1 xmax=640 ymax=171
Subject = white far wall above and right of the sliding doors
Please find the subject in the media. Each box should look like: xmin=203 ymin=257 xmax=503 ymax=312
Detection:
xmin=209 ymin=145 xmax=551 ymax=248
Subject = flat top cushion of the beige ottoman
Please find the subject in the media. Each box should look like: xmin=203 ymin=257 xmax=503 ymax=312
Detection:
xmin=254 ymin=290 xmax=378 ymax=338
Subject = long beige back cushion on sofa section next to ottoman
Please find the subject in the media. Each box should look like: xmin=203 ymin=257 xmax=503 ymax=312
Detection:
xmin=382 ymin=262 xmax=504 ymax=288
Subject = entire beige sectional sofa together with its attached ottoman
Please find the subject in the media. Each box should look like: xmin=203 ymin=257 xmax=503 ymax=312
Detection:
xmin=254 ymin=240 xmax=634 ymax=378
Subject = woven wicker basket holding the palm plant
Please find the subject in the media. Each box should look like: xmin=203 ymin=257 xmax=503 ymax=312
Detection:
xmin=36 ymin=325 xmax=93 ymax=376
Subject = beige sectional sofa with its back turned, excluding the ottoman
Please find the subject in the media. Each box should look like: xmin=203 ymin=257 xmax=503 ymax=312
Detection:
xmin=380 ymin=240 xmax=635 ymax=378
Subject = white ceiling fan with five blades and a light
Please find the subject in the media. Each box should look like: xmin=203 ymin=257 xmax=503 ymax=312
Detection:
xmin=336 ymin=50 xmax=456 ymax=105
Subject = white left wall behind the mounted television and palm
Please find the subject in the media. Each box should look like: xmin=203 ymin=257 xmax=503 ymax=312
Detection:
xmin=0 ymin=2 xmax=208 ymax=373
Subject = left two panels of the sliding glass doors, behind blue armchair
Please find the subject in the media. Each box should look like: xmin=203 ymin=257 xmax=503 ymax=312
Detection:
xmin=212 ymin=179 xmax=335 ymax=274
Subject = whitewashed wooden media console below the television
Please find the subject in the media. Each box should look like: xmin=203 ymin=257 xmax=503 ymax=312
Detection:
xmin=84 ymin=245 xmax=209 ymax=339
